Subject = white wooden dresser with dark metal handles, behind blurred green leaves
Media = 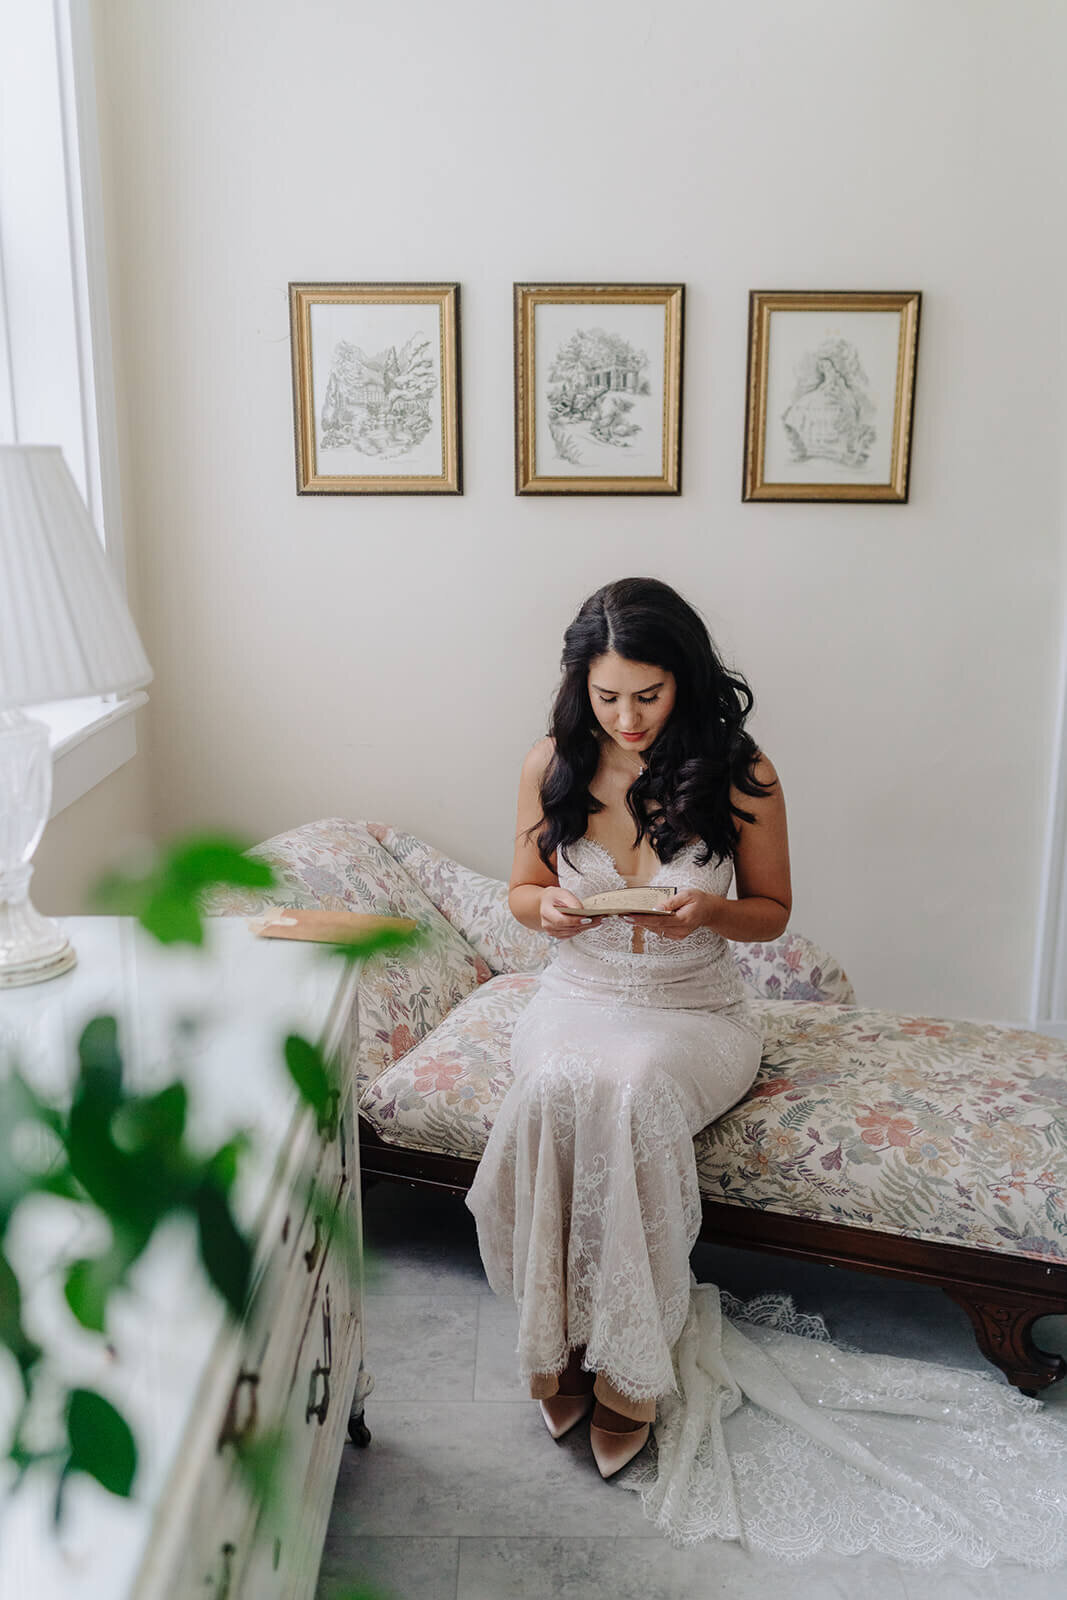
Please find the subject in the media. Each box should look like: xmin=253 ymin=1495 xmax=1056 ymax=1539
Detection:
xmin=0 ymin=917 xmax=371 ymax=1600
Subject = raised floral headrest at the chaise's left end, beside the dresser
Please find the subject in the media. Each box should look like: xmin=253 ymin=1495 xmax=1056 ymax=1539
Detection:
xmin=205 ymin=818 xmax=491 ymax=1093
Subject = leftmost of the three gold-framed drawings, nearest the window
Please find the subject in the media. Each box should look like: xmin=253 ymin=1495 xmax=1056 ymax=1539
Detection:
xmin=290 ymin=283 xmax=462 ymax=494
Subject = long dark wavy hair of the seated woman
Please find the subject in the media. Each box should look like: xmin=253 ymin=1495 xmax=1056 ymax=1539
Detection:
xmin=530 ymin=578 xmax=774 ymax=866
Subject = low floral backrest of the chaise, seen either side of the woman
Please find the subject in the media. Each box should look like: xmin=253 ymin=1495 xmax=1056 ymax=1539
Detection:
xmin=366 ymin=822 xmax=856 ymax=1005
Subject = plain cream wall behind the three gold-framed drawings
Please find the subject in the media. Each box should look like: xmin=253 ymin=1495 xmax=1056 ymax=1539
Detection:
xmin=89 ymin=0 xmax=1067 ymax=1018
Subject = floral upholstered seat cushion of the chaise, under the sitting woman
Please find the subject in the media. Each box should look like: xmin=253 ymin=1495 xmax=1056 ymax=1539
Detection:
xmin=362 ymin=974 xmax=1067 ymax=1261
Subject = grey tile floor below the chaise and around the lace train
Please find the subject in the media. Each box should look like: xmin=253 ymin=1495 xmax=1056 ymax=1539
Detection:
xmin=318 ymin=1182 xmax=1067 ymax=1600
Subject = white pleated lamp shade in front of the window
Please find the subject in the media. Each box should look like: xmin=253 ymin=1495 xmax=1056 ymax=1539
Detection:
xmin=0 ymin=445 xmax=152 ymax=710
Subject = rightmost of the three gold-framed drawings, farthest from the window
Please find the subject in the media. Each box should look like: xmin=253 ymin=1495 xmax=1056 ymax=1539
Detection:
xmin=742 ymin=290 xmax=921 ymax=504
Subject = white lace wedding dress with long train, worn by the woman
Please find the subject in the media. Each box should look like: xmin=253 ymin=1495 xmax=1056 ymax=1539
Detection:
xmin=467 ymin=838 xmax=1067 ymax=1568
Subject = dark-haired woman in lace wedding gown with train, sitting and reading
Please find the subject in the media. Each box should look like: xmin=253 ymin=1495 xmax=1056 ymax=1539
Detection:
xmin=467 ymin=578 xmax=1067 ymax=1566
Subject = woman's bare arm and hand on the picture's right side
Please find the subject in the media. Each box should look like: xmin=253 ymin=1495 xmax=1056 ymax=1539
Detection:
xmin=630 ymin=755 xmax=793 ymax=944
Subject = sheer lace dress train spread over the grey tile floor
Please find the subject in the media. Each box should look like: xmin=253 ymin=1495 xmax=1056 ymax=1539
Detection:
xmin=617 ymin=1278 xmax=1067 ymax=1568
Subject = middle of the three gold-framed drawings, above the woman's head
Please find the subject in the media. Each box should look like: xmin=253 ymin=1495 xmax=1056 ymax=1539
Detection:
xmin=515 ymin=283 xmax=685 ymax=494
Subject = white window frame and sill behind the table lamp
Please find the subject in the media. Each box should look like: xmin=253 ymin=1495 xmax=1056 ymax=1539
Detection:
xmin=0 ymin=0 xmax=147 ymax=816
